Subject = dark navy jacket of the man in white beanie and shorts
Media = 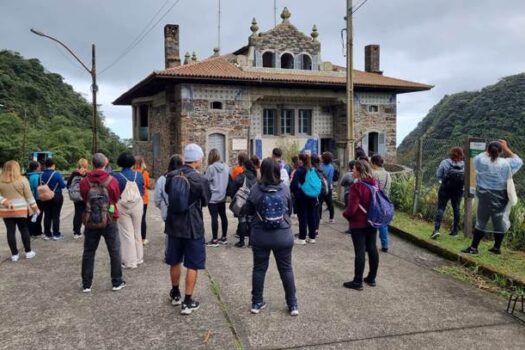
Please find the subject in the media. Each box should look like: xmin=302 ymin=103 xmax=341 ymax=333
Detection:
xmin=165 ymin=166 xmax=211 ymax=239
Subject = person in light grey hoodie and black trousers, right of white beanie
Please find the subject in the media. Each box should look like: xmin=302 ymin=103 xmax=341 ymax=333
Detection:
xmin=204 ymin=148 xmax=230 ymax=247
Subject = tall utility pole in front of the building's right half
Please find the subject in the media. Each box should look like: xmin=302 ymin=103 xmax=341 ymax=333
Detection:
xmin=345 ymin=0 xmax=355 ymax=164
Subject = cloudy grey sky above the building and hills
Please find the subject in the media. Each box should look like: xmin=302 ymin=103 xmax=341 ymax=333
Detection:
xmin=0 ymin=0 xmax=525 ymax=142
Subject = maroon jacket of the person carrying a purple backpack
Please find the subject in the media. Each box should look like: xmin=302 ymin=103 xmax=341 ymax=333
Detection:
xmin=343 ymin=179 xmax=378 ymax=229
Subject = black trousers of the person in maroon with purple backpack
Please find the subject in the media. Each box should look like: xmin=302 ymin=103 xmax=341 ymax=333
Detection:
xmin=352 ymin=226 xmax=379 ymax=283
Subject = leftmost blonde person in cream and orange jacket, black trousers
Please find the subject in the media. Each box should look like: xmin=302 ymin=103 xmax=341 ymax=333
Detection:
xmin=0 ymin=160 xmax=39 ymax=262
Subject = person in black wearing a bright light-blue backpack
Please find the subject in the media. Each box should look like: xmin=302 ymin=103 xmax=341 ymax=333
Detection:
xmin=290 ymin=153 xmax=322 ymax=245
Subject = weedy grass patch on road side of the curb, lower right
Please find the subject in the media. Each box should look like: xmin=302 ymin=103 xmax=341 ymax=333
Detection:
xmin=434 ymin=265 xmax=525 ymax=299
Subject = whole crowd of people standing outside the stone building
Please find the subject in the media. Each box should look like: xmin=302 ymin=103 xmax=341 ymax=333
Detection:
xmin=0 ymin=141 xmax=523 ymax=316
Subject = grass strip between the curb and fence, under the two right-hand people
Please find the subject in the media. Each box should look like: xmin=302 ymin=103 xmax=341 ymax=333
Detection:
xmin=392 ymin=212 xmax=525 ymax=281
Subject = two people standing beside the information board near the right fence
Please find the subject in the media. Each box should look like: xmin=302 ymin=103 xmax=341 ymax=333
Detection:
xmin=431 ymin=140 xmax=523 ymax=255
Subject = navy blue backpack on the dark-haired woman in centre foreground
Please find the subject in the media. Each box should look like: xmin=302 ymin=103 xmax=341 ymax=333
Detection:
xmin=256 ymin=189 xmax=288 ymax=230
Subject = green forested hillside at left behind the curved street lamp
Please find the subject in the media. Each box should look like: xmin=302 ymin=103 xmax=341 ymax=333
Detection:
xmin=0 ymin=50 xmax=126 ymax=169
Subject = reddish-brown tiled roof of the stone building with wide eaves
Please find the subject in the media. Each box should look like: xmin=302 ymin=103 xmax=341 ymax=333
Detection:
xmin=113 ymin=54 xmax=433 ymax=105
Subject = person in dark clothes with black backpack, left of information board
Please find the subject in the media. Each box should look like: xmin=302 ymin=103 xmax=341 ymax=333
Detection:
xmin=430 ymin=147 xmax=465 ymax=239
